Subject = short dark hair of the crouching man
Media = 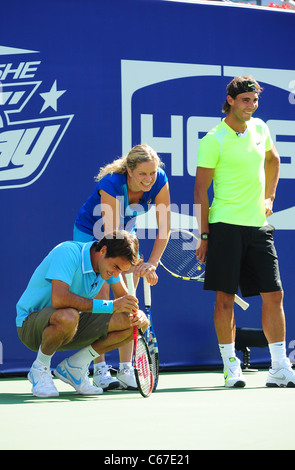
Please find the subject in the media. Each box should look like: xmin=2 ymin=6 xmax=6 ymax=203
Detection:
xmin=93 ymin=230 xmax=141 ymax=266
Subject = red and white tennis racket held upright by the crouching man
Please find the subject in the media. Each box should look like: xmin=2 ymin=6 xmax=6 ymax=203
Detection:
xmin=125 ymin=273 xmax=153 ymax=398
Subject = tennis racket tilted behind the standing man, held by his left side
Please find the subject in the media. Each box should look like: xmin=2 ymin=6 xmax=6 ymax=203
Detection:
xmin=160 ymin=229 xmax=249 ymax=310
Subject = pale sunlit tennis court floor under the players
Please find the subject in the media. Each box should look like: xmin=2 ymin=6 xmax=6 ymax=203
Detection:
xmin=0 ymin=370 xmax=295 ymax=452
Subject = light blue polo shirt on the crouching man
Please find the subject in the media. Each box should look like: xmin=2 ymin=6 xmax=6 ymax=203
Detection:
xmin=16 ymin=241 xmax=121 ymax=326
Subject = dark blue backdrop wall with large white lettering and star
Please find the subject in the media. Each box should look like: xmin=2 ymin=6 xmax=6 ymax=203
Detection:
xmin=0 ymin=0 xmax=295 ymax=373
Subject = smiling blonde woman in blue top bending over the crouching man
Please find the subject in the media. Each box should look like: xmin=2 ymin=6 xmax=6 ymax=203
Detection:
xmin=74 ymin=144 xmax=170 ymax=390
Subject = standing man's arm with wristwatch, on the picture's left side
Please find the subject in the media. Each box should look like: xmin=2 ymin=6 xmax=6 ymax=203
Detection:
xmin=194 ymin=167 xmax=214 ymax=263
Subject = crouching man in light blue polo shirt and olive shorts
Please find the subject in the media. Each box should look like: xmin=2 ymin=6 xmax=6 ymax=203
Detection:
xmin=16 ymin=231 xmax=148 ymax=397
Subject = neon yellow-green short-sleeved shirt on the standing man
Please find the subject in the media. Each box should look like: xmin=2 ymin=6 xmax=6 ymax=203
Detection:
xmin=197 ymin=118 xmax=272 ymax=227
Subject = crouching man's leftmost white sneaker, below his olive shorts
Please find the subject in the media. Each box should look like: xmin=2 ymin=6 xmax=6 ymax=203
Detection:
xmin=28 ymin=364 xmax=59 ymax=398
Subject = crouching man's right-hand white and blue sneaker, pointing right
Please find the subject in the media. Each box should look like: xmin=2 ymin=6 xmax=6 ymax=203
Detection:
xmin=53 ymin=359 xmax=103 ymax=395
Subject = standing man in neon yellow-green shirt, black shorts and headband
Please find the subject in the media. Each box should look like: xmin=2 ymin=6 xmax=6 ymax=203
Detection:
xmin=195 ymin=76 xmax=295 ymax=387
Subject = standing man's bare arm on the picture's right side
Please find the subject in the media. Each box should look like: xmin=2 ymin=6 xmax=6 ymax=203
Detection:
xmin=264 ymin=145 xmax=280 ymax=217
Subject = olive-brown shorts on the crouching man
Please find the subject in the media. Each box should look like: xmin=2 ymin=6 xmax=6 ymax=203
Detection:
xmin=17 ymin=307 xmax=112 ymax=351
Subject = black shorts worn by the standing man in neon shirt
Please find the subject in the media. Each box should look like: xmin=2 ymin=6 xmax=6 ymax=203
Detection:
xmin=204 ymin=222 xmax=282 ymax=297
